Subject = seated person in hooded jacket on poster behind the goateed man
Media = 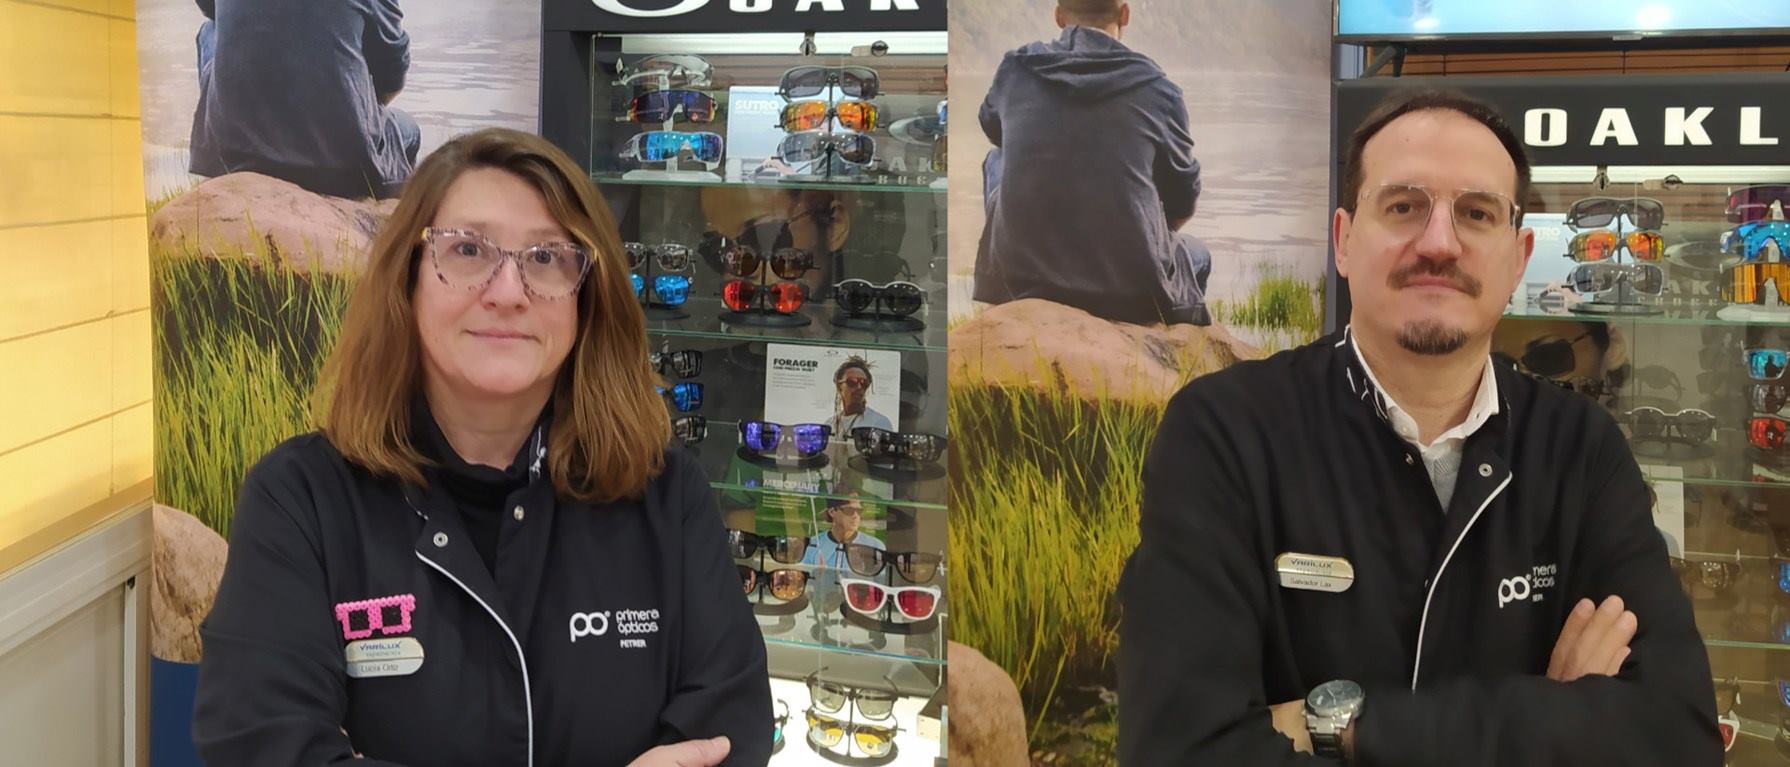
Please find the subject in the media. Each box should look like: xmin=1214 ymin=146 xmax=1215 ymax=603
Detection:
xmin=974 ymin=0 xmax=1212 ymax=324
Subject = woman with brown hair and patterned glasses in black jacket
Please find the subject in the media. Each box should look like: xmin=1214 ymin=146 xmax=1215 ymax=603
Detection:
xmin=193 ymin=131 xmax=771 ymax=767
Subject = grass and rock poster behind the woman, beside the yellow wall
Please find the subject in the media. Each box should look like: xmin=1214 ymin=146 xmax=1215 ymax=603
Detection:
xmin=136 ymin=0 xmax=541 ymax=767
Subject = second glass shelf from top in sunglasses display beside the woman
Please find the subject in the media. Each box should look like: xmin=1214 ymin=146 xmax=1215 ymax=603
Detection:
xmin=646 ymin=296 xmax=947 ymax=353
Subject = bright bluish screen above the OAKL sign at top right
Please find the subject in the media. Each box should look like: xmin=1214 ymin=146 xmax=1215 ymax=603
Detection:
xmin=1335 ymin=0 xmax=1790 ymax=41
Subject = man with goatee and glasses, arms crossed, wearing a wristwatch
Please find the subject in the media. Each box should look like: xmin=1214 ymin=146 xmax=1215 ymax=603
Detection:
xmin=1119 ymin=91 xmax=1722 ymax=767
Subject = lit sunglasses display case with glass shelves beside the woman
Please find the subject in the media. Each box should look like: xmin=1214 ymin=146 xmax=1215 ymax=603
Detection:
xmin=542 ymin=2 xmax=950 ymax=765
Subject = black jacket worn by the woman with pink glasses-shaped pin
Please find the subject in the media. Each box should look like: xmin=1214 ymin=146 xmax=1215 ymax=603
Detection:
xmin=193 ymin=430 xmax=771 ymax=767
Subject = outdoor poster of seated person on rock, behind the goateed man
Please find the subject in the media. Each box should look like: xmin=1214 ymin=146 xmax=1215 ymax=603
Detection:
xmin=949 ymin=0 xmax=1330 ymax=765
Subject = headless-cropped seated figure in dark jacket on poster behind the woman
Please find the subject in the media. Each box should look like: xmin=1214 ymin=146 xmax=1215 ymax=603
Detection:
xmin=190 ymin=0 xmax=422 ymax=199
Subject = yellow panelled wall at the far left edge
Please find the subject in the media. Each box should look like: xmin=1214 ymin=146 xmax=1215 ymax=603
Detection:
xmin=0 ymin=0 xmax=150 ymax=570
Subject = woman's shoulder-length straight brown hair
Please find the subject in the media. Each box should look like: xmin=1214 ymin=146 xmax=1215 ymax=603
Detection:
xmin=313 ymin=129 xmax=671 ymax=502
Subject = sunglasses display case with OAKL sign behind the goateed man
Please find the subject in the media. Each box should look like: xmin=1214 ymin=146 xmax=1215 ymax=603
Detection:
xmin=1330 ymin=75 xmax=1790 ymax=765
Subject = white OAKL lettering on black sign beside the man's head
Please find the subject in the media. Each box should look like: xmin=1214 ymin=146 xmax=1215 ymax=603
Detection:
xmin=1523 ymin=106 xmax=1777 ymax=147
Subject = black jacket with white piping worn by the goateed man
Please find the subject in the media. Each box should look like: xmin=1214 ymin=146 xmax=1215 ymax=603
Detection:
xmin=1119 ymin=332 xmax=1722 ymax=767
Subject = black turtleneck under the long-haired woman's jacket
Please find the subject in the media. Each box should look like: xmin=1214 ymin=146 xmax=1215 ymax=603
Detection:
xmin=412 ymin=398 xmax=550 ymax=573
